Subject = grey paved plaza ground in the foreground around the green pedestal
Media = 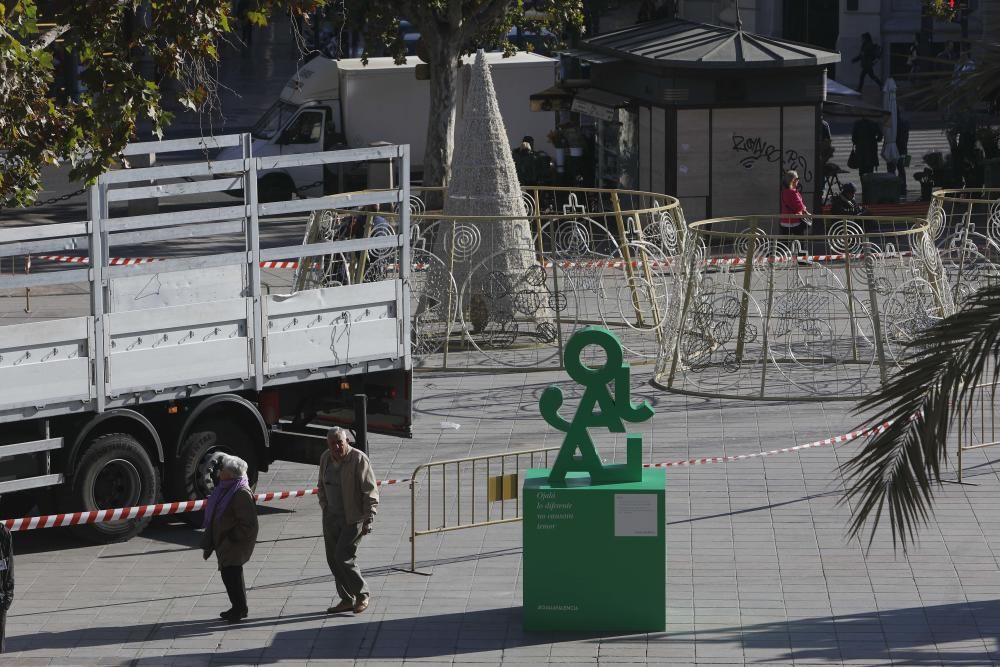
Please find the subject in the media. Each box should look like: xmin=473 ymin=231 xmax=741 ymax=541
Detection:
xmin=0 ymin=367 xmax=1000 ymax=665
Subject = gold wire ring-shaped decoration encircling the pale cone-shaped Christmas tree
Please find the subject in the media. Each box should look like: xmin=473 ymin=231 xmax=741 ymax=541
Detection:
xmin=324 ymin=188 xmax=686 ymax=372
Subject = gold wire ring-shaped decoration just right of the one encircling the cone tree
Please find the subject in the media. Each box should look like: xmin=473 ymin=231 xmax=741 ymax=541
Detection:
xmin=654 ymin=216 xmax=954 ymax=400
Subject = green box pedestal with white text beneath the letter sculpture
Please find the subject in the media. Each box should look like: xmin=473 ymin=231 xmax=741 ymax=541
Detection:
xmin=522 ymin=468 xmax=667 ymax=632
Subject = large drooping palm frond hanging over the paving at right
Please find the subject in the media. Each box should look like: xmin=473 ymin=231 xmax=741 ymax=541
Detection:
xmin=841 ymin=285 xmax=1000 ymax=549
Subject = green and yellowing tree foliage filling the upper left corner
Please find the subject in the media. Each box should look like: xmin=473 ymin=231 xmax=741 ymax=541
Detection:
xmin=0 ymin=0 xmax=326 ymax=205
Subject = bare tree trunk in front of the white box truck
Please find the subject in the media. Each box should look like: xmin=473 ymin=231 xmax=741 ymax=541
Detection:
xmin=423 ymin=34 xmax=459 ymax=196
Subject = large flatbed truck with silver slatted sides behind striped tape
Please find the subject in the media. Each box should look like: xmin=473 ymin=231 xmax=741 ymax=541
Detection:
xmin=0 ymin=134 xmax=412 ymax=540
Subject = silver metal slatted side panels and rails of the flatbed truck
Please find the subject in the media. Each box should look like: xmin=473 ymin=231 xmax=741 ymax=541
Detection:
xmin=0 ymin=135 xmax=410 ymax=422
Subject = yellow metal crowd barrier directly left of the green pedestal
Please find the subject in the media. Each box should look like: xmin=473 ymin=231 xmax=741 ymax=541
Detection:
xmin=410 ymin=447 xmax=559 ymax=574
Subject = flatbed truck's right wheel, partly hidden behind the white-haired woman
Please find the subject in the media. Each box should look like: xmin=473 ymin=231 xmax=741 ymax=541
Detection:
xmin=170 ymin=419 xmax=258 ymax=526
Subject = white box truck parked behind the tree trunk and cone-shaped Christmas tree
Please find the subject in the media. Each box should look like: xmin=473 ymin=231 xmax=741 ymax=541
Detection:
xmin=233 ymin=52 xmax=558 ymax=201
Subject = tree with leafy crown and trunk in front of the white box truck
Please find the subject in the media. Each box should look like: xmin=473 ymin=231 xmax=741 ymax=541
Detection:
xmin=345 ymin=0 xmax=584 ymax=185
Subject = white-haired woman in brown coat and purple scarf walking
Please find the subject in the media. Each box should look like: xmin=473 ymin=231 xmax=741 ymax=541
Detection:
xmin=202 ymin=454 xmax=258 ymax=623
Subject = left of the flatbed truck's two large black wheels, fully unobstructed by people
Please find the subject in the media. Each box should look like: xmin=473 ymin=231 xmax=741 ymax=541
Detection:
xmin=70 ymin=433 xmax=160 ymax=543
